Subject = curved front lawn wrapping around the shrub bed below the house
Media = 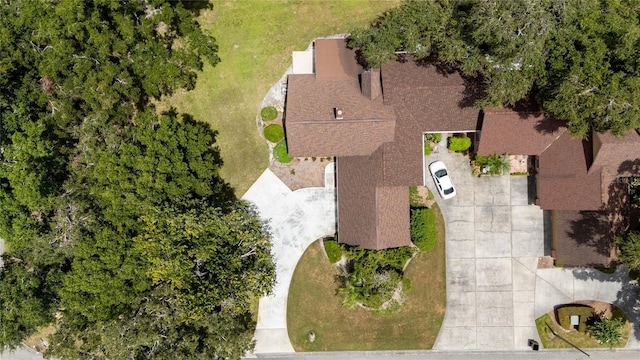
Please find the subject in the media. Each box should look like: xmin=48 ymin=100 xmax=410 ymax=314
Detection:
xmin=287 ymin=207 xmax=446 ymax=351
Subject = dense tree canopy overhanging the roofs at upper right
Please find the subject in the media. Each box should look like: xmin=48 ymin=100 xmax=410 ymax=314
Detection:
xmin=350 ymin=0 xmax=640 ymax=137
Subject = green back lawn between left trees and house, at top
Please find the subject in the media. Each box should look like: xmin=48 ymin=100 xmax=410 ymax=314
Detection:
xmin=160 ymin=0 xmax=399 ymax=196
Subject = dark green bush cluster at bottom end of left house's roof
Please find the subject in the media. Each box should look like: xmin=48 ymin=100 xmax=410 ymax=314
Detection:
xmin=338 ymin=246 xmax=415 ymax=314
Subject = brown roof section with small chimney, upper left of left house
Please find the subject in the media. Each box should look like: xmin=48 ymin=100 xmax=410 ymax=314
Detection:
xmin=285 ymin=39 xmax=395 ymax=156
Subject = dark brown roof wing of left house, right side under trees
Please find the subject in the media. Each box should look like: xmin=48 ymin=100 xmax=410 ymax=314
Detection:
xmin=381 ymin=59 xmax=478 ymax=132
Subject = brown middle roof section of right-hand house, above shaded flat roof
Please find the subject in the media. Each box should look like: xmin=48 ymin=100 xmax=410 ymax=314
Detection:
xmin=537 ymin=132 xmax=603 ymax=210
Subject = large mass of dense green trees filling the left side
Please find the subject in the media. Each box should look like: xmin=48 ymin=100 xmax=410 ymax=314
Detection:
xmin=0 ymin=0 xmax=274 ymax=359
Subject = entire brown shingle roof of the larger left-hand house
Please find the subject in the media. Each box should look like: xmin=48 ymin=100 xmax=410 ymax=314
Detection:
xmin=285 ymin=39 xmax=478 ymax=249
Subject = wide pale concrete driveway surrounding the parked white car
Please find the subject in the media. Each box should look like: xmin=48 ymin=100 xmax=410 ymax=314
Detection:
xmin=425 ymin=153 xmax=640 ymax=350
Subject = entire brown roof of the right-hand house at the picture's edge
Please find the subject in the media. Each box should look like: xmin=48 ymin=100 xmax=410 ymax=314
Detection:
xmin=477 ymin=109 xmax=640 ymax=266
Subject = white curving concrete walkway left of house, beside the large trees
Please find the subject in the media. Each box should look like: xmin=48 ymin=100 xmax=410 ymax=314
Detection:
xmin=242 ymin=169 xmax=336 ymax=353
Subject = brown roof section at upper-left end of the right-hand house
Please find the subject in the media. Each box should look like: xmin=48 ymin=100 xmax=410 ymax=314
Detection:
xmin=478 ymin=108 xmax=567 ymax=156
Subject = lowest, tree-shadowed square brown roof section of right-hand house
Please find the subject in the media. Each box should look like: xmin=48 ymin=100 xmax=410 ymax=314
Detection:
xmin=551 ymin=211 xmax=612 ymax=266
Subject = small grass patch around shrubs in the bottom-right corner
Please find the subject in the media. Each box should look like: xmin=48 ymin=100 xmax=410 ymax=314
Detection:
xmin=536 ymin=314 xmax=631 ymax=349
